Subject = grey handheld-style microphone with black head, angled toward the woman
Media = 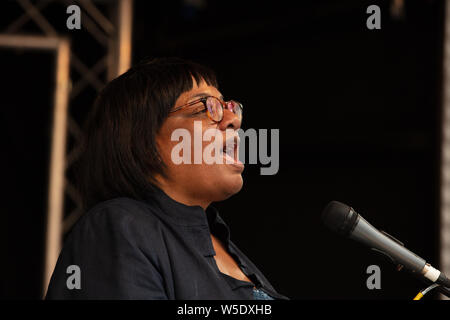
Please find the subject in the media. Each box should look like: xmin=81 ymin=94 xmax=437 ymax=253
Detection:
xmin=322 ymin=201 xmax=450 ymax=288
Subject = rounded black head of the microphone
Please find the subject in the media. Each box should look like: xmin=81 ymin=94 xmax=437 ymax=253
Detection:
xmin=322 ymin=201 xmax=359 ymax=236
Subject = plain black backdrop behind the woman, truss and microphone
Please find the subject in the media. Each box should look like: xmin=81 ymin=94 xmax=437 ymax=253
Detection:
xmin=0 ymin=0 xmax=444 ymax=299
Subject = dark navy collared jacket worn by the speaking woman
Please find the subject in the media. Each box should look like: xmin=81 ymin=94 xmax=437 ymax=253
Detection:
xmin=46 ymin=190 xmax=288 ymax=300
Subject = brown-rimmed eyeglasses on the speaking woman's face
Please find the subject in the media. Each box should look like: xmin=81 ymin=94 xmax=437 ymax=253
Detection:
xmin=169 ymin=96 xmax=244 ymax=122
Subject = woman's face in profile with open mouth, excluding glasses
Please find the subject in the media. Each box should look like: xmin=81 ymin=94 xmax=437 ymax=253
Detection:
xmin=156 ymin=80 xmax=244 ymax=208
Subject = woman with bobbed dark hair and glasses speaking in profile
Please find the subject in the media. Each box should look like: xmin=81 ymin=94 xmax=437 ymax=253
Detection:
xmin=47 ymin=58 xmax=287 ymax=299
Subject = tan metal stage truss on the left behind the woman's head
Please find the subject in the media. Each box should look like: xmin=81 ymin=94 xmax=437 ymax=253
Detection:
xmin=0 ymin=0 xmax=133 ymax=296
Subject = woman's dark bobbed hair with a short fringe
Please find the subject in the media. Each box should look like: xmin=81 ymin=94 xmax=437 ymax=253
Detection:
xmin=75 ymin=58 xmax=218 ymax=209
